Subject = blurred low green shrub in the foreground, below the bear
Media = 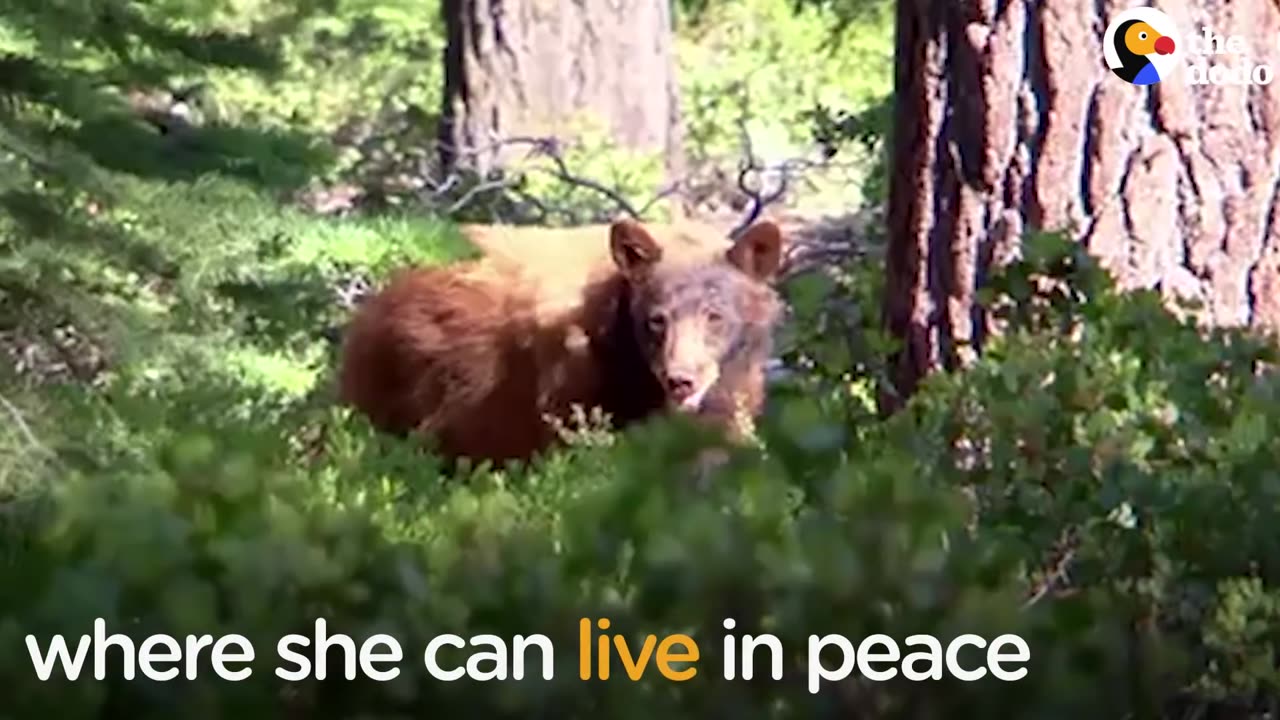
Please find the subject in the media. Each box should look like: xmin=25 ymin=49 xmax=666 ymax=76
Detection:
xmin=0 ymin=368 xmax=1111 ymax=717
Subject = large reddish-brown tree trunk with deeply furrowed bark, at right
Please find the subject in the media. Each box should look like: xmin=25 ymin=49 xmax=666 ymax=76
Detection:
xmin=886 ymin=0 xmax=1280 ymax=406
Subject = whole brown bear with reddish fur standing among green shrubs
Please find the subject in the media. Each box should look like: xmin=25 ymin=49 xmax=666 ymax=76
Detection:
xmin=339 ymin=220 xmax=782 ymax=462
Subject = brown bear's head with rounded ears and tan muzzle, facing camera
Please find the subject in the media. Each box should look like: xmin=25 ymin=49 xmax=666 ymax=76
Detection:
xmin=609 ymin=215 xmax=782 ymax=414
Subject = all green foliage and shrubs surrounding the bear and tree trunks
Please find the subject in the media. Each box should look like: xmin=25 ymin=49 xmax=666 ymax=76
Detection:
xmin=0 ymin=0 xmax=1280 ymax=719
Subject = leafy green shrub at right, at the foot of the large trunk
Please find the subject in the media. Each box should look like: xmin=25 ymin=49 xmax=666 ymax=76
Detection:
xmin=901 ymin=236 xmax=1280 ymax=711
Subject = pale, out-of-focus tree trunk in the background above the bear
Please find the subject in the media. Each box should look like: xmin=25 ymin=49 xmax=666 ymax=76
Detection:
xmin=440 ymin=0 xmax=682 ymax=183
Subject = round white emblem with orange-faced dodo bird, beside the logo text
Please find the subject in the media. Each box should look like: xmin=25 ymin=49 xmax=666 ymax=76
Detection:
xmin=1102 ymin=8 xmax=1181 ymax=85
